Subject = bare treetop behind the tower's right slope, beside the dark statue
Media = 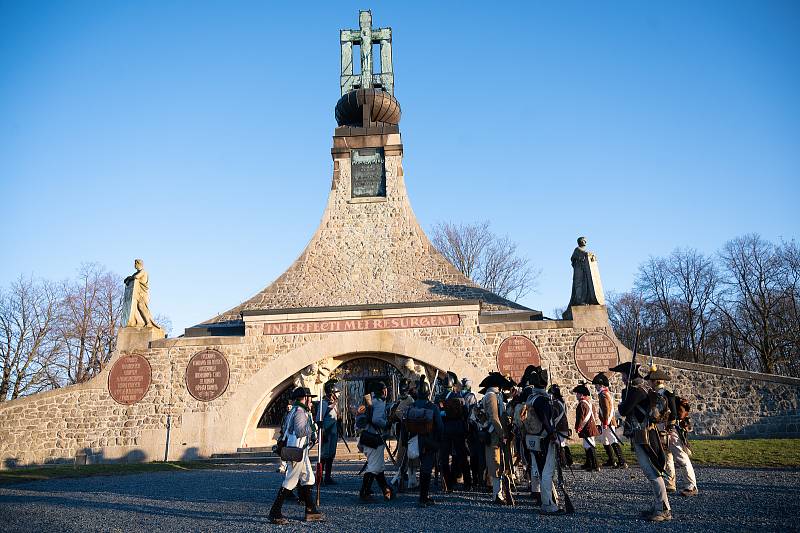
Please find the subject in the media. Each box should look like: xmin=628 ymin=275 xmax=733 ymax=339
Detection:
xmin=431 ymin=222 xmax=540 ymax=300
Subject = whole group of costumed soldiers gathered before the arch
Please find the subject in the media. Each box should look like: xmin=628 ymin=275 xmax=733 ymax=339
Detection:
xmin=270 ymin=362 xmax=697 ymax=524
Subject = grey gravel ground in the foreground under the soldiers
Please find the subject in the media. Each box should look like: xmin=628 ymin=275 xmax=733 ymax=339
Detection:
xmin=0 ymin=463 xmax=800 ymax=533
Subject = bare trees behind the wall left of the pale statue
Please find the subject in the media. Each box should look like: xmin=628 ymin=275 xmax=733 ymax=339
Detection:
xmin=0 ymin=263 xmax=169 ymax=402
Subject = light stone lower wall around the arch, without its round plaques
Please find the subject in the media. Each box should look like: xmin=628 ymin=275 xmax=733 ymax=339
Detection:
xmin=0 ymin=303 xmax=800 ymax=467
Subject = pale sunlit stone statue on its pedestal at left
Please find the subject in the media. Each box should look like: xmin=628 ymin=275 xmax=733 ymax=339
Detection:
xmin=117 ymin=259 xmax=166 ymax=352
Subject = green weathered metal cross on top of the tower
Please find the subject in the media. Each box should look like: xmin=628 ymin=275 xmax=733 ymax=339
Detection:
xmin=340 ymin=11 xmax=394 ymax=95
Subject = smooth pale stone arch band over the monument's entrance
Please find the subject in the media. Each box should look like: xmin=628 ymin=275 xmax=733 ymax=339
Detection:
xmin=201 ymin=331 xmax=484 ymax=455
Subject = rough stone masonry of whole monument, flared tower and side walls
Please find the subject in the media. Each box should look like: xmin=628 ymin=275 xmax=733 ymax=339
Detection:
xmin=0 ymin=7 xmax=800 ymax=468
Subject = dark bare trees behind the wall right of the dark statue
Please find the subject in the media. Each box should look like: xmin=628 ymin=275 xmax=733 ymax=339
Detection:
xmin=607 ymin=234 xmax=800 ymax=376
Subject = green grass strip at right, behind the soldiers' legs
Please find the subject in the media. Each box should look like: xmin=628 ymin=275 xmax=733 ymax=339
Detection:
xmin=570 ymin=439 xmax=800 ymax=468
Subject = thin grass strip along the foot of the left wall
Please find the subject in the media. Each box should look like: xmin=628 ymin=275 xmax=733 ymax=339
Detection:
xmin=0 ymin=462 xmax=216 ymax=485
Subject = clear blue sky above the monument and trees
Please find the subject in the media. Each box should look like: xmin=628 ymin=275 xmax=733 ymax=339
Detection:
xmin=0 ymin=0 xmax=800 ymax=334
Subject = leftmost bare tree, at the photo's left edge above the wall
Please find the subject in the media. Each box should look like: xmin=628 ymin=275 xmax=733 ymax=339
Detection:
xmin=0 ymin=277 xmax=58 ymax=402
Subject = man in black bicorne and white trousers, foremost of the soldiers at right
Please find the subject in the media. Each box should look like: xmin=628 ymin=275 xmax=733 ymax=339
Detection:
xmin=609 ymin=362 xmax=672 ymax=522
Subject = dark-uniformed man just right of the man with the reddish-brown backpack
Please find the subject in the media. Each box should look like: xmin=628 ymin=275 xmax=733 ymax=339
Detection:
xmin=436 ymin=372 xmax=472 ymax=492
